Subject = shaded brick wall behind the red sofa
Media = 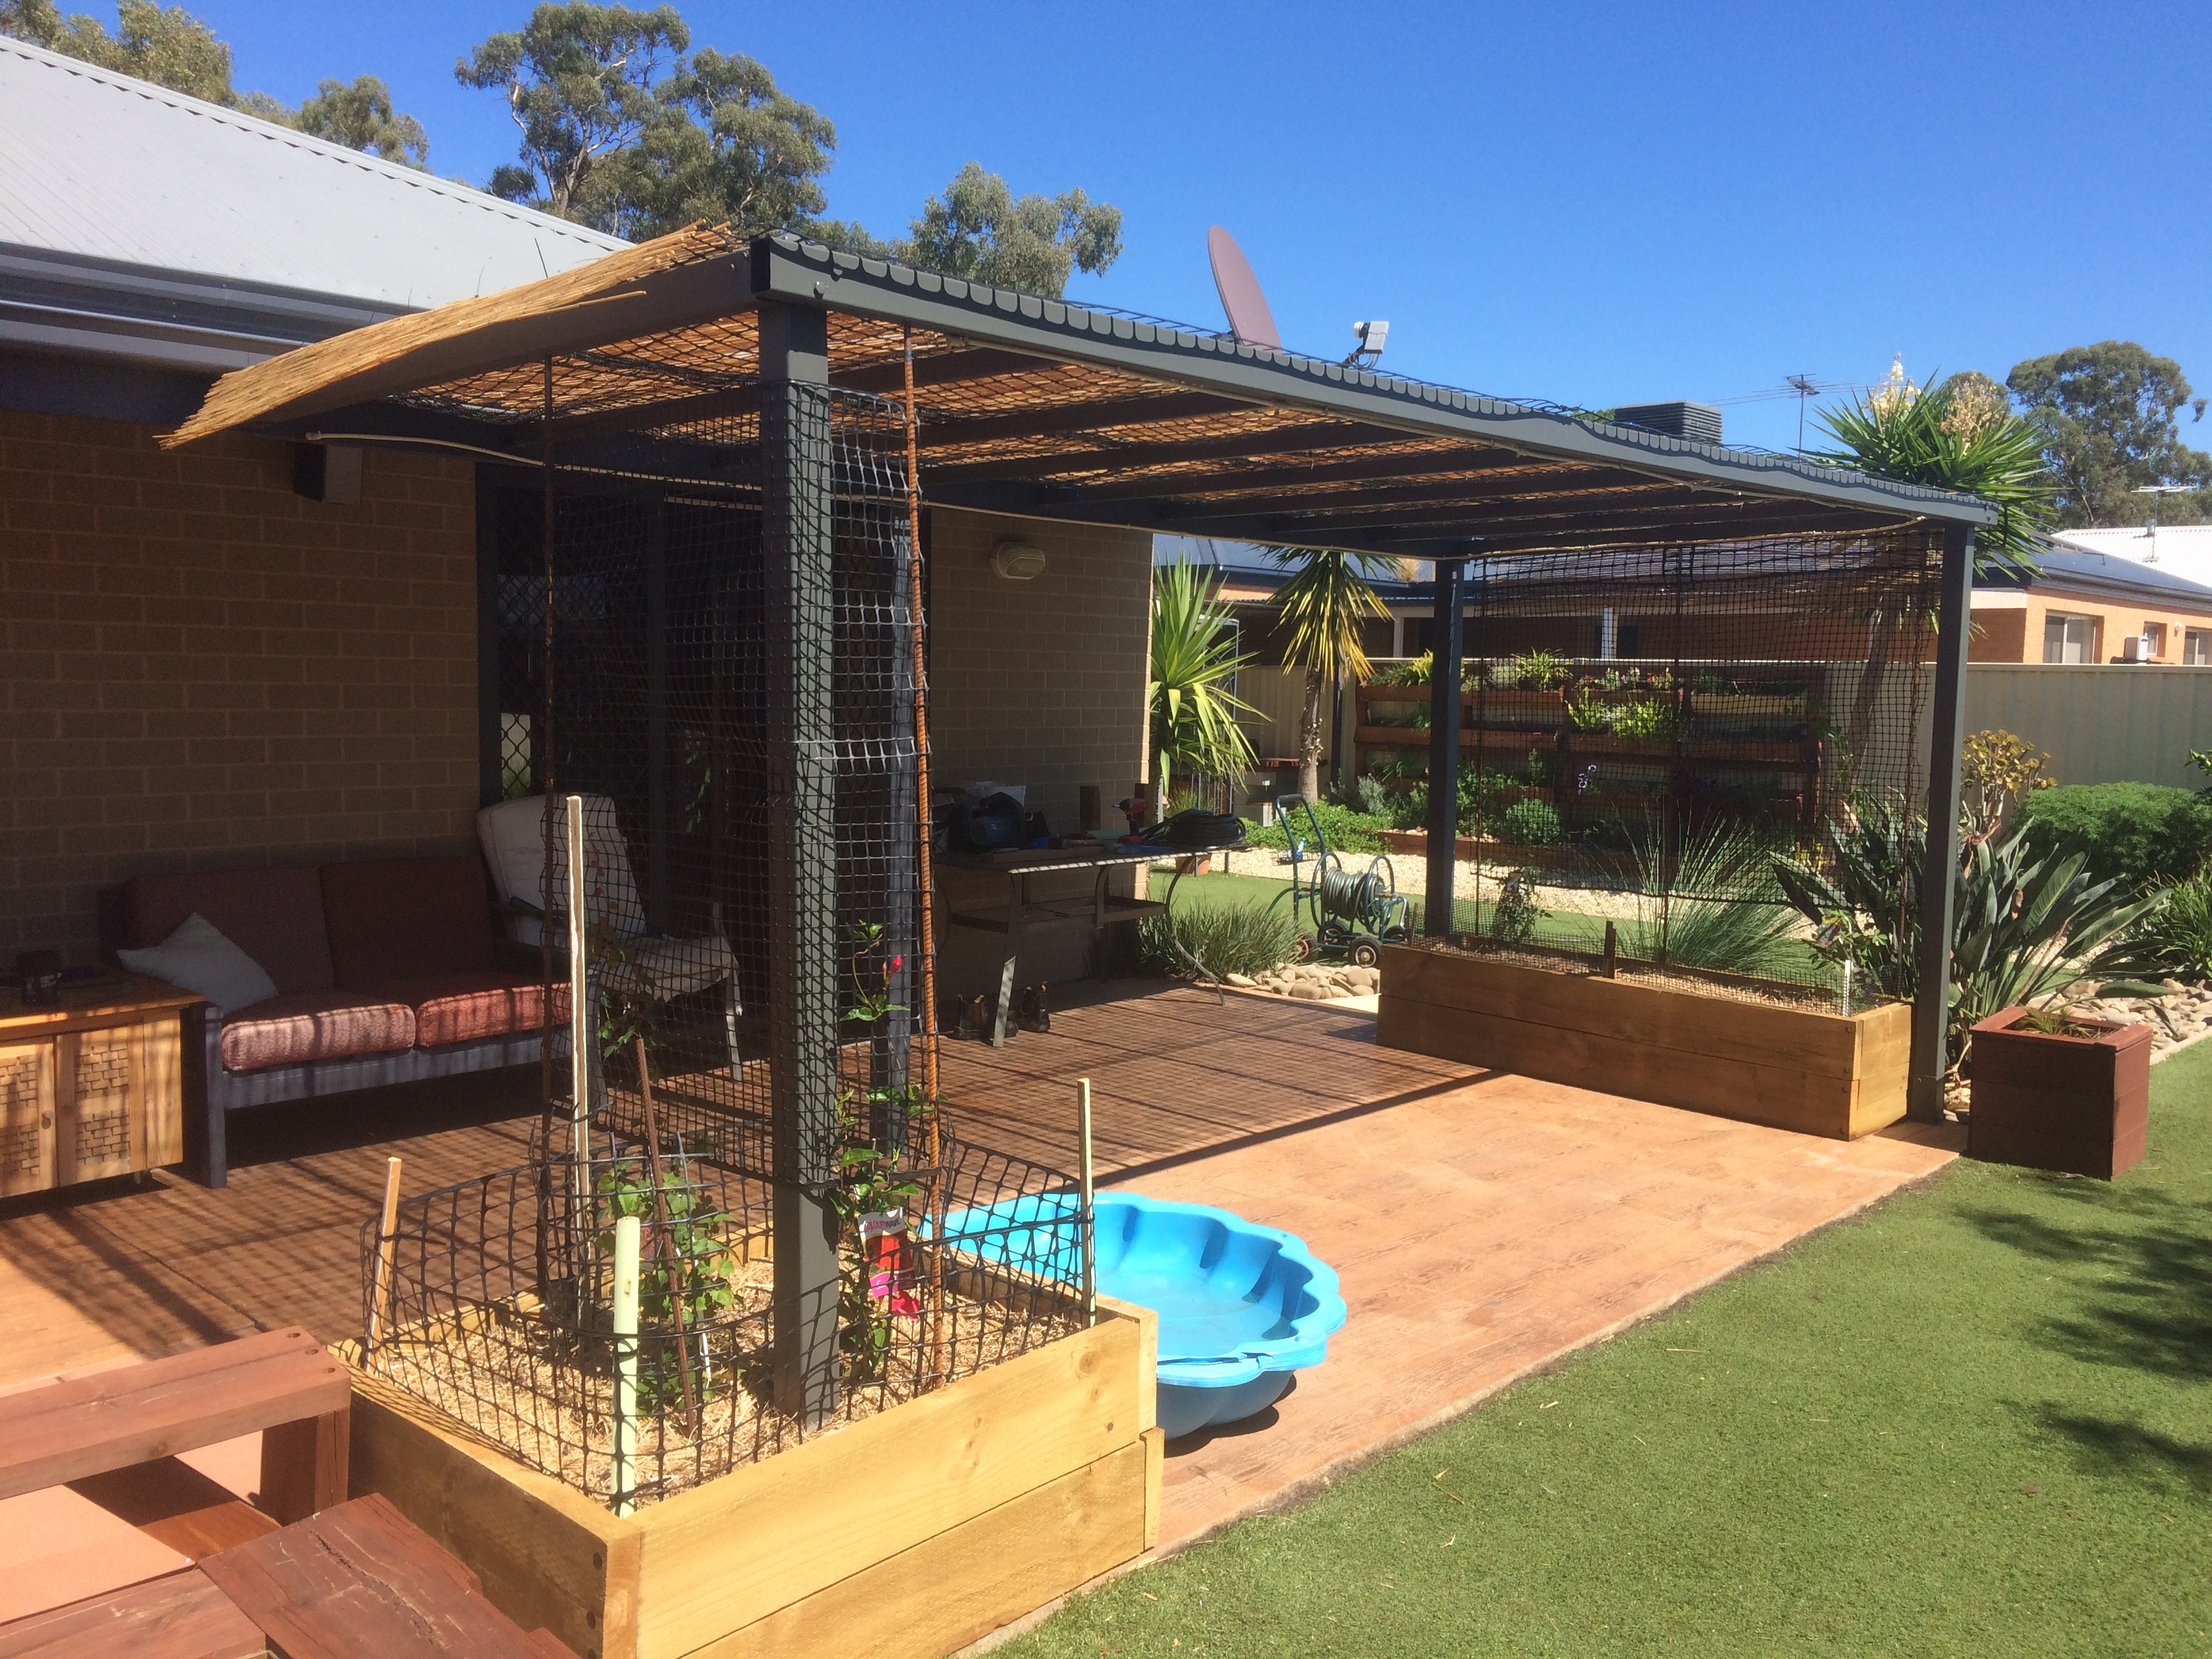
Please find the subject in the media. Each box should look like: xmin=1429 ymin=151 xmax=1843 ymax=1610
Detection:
xmin=0 ymin=411 xmax=478 ymax=966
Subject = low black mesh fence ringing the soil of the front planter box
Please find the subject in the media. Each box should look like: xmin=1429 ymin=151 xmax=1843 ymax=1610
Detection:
xmin=361 ymin=1134 xmax=1086 ymax=1507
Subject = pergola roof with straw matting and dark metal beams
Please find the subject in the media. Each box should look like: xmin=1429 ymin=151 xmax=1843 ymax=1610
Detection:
xmin=173 ymin=230 xmax=1995 ymax=560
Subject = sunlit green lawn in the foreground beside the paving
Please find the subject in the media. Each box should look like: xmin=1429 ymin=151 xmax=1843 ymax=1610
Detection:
xmin=1002 ymin=1044 xmax=2212 ymax=1659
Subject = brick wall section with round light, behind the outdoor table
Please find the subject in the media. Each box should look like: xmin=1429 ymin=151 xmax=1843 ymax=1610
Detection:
xmin=929 ymin=509 xmax=1153 ymax=994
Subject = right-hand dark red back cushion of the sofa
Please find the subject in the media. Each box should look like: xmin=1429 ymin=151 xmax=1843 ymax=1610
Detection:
xmin=321 ymin=854 xmax=495 ymax=991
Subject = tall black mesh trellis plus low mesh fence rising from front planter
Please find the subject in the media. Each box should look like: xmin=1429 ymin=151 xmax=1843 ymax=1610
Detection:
xmin=363 ymin=369 xmax=1082 ymax=1507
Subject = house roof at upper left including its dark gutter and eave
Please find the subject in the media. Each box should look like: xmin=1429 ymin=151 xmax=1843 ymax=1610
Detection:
xmin=0 ymin=40 xmax=626 ymax=425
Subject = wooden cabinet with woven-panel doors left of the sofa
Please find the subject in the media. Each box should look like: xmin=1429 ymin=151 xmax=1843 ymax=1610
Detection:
xmin=0 ymin=978 xmax=201 ymax=1197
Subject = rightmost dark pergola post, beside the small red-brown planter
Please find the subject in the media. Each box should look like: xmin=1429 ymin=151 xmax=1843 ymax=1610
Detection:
xmin=1904 ymin=525 xmax=1973 ymax=1124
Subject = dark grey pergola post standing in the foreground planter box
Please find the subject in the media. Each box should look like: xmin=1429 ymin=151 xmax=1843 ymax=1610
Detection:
xmin=761 ymin=305 xmax=840 ymax=1427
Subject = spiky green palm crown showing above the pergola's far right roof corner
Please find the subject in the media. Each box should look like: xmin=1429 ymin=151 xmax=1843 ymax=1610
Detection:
xmin=1811 ymin=365 xmax=2053 ymax=577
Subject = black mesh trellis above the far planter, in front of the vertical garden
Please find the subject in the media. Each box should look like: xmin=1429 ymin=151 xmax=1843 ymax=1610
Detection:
xmin=1360 ymin=529 xmax=1940 ymax=1011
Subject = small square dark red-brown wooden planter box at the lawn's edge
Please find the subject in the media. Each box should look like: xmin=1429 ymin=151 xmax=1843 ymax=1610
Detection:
xmin=1967 ymin=1008 xmax=2150 ymax=1181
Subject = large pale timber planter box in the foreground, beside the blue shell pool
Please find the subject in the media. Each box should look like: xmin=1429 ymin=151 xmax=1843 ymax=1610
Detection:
xmin=352 ymin=1300 xmax=1164 ymax=1659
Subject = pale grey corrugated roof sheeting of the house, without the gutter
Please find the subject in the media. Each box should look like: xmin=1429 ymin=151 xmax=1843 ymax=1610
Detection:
xmin=0 ymin=40 xmax=626 ymax=310
